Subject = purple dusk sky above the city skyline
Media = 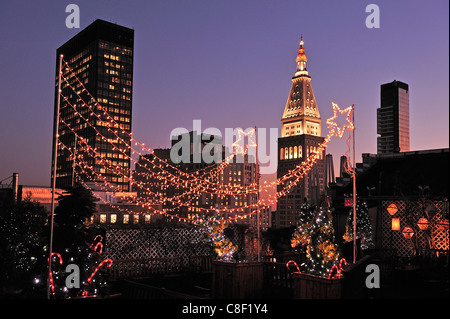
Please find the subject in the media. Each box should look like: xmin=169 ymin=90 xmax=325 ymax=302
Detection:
xmin=0 ymin=0 xmax=449 ymax=186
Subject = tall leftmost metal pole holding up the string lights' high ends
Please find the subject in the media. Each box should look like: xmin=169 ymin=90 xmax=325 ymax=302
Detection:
xmin=47 ymin=54 xmax=63 ymax=299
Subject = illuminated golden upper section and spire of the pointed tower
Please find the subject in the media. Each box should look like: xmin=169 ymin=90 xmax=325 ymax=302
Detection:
xmin=281 ymin=35 xmax=322 ymax=137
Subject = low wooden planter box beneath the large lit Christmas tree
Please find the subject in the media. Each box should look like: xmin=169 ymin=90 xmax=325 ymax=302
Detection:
xmin=294 ymin=273 xmax=343 ymax=299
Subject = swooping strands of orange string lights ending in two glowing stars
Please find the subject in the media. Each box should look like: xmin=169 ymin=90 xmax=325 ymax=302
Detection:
xmin=55 ymin=61 xmax=354 ymax=224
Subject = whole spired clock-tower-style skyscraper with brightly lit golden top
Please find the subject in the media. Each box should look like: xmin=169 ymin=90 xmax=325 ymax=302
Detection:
xmin=275 ymin=36 xmax=325 ymax=228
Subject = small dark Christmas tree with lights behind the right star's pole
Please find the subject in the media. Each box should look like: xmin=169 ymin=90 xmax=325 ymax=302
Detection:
xmin=342 ymin=201 xmax=373 ymax=249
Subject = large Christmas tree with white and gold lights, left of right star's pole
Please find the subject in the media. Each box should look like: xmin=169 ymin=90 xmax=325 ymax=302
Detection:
xmin=291 ymin=200 xmax=339 ymax=277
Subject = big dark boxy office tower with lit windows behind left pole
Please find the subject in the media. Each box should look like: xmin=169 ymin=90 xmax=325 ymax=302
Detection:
xmin=52 ymin=20 xmax=134 ymax=191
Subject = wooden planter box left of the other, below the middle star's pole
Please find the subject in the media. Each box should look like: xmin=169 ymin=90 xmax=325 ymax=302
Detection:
xmin=212 ymin=261 xmax=263 ymax=299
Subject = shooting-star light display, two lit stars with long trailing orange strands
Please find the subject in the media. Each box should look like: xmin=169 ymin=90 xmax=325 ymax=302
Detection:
xmin=58 ymin=61 xmax=354 ymax=225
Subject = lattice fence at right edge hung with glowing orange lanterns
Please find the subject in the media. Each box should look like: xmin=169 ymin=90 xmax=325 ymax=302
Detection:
xmin=380 ymin=200 xmax=449 ymax=257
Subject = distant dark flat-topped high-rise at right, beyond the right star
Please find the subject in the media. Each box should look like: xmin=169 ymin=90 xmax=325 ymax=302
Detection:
xmin=377 ymin=81 xmax=409 ymax=154
